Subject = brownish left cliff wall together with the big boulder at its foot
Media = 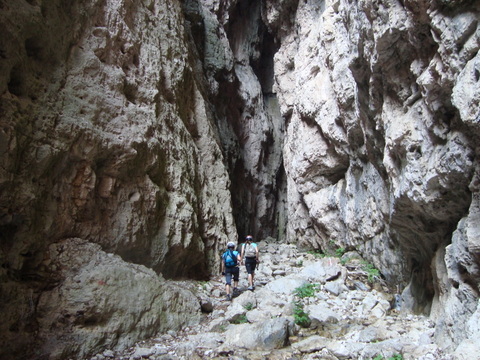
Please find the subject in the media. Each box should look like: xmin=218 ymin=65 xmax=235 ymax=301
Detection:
xmin=0 ymin=0 xmax=237 ymax=359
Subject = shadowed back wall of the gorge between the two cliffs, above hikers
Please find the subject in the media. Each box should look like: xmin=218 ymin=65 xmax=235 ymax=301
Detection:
xmin=186 ymin=0 xmax=287 ymax=241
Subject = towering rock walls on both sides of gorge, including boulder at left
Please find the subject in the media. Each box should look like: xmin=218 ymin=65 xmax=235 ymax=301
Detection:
xmin=0 ymin=0 xmax=480 ymax=360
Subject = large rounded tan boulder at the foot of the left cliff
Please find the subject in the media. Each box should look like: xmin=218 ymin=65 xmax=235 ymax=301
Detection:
xmin=35 ymin=239 xmax=200 ymax=359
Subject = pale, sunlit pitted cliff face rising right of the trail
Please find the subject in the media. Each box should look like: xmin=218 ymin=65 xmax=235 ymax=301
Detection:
xmin=264 ymin=0 xmax=480 ymax=348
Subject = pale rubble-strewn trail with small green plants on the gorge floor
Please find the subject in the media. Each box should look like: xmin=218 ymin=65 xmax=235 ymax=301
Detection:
xmin=91 ymin=241 xmax=457 ymax=360
